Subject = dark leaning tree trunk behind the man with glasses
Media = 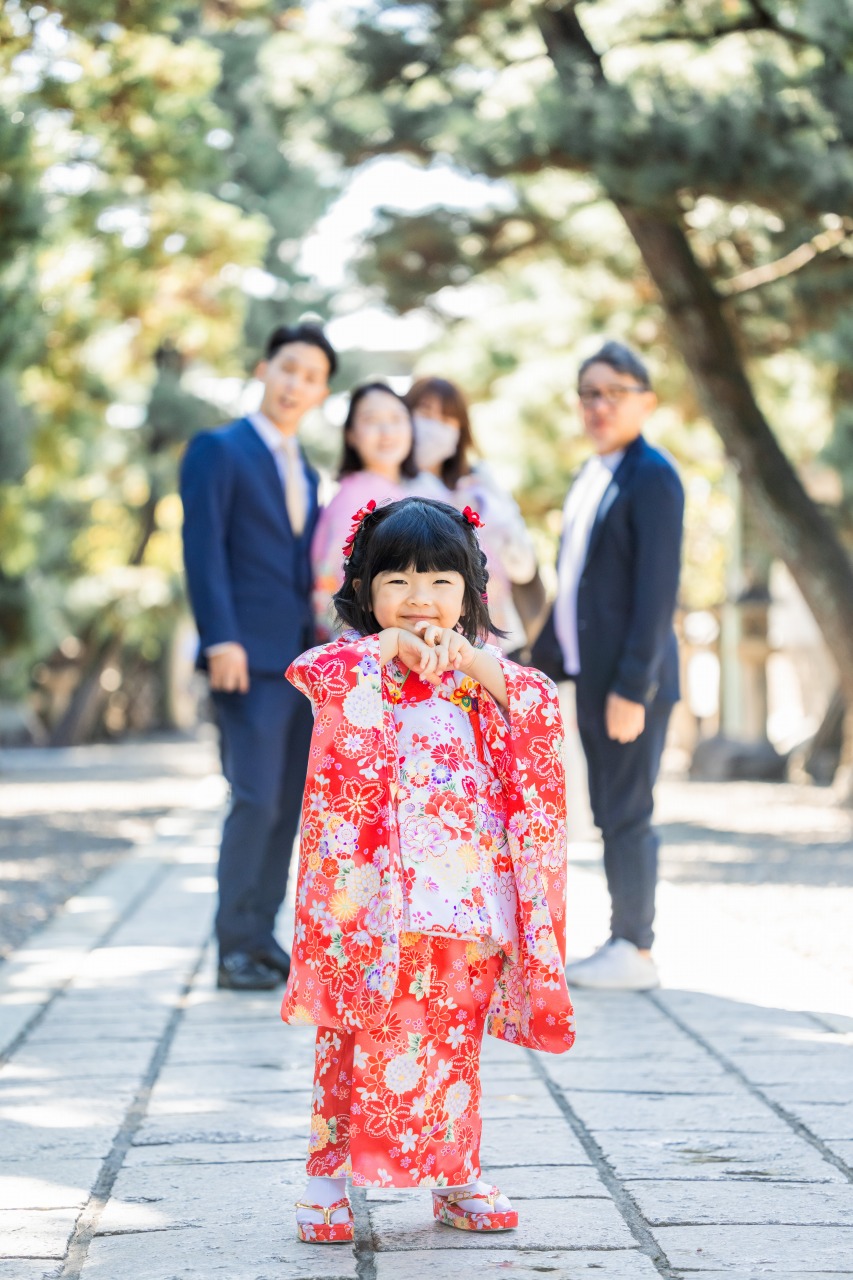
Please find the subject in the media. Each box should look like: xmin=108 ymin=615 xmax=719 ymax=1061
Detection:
xmin=539 ymin=4 xmax=853 ymax=781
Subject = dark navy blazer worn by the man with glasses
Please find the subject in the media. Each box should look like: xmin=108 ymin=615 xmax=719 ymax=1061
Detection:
xmin=532 ymin=435 xmax=684 ymax=716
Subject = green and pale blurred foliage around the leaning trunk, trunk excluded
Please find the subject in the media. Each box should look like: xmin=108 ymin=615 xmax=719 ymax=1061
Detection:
xmin=257 ymin=0 xmax=853 ymax=604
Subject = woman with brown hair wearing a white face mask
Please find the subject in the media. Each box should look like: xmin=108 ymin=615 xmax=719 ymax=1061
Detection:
xmin=405 ymin=378 xmax=544 ymax=657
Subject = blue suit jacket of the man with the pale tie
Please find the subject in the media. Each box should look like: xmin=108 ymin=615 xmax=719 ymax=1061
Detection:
xmin=181 ymin=417 xmax=318 ymax=675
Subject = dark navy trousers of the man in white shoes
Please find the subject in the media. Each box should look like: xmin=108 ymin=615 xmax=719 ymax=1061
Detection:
xmin=578 ymin=701 xmax=672 ymax=950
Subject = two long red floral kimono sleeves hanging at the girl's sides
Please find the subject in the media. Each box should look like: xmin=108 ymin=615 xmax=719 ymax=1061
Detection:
xmin=282 ymin=634 xmax=574 ymax=1053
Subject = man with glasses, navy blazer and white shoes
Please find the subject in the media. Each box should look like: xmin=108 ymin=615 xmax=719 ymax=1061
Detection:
xmin=532 ymin=342 xmax=684 ymax=991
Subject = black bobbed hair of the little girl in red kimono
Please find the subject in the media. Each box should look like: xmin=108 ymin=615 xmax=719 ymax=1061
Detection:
xmin=333 ymin=498 xmax=503 ymax=644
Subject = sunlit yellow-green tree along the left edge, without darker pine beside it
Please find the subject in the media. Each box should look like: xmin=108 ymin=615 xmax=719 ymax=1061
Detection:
xmin=0 ymin=0 xmax=269 ymax=741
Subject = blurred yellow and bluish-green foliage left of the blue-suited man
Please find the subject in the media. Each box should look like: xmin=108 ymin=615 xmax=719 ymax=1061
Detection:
xmin=0 ymin=0 xmax=334 ymax=742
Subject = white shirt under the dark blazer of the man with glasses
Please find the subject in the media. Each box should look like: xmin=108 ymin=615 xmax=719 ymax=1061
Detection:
xmin=553 ymin=449 xmax=625 ymax=676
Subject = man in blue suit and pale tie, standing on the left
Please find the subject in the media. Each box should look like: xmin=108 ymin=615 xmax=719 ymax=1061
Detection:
xmin=181 ymin=324 xmax=337 ymax=991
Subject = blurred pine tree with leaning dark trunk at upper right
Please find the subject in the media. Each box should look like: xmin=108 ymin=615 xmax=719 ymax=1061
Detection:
xmin=269 ymin=0 xmax=853 ymax=757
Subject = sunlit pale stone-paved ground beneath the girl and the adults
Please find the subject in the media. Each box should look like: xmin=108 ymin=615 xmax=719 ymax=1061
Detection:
xmin=0 ymin=746 xmax=853 ymax=1280
